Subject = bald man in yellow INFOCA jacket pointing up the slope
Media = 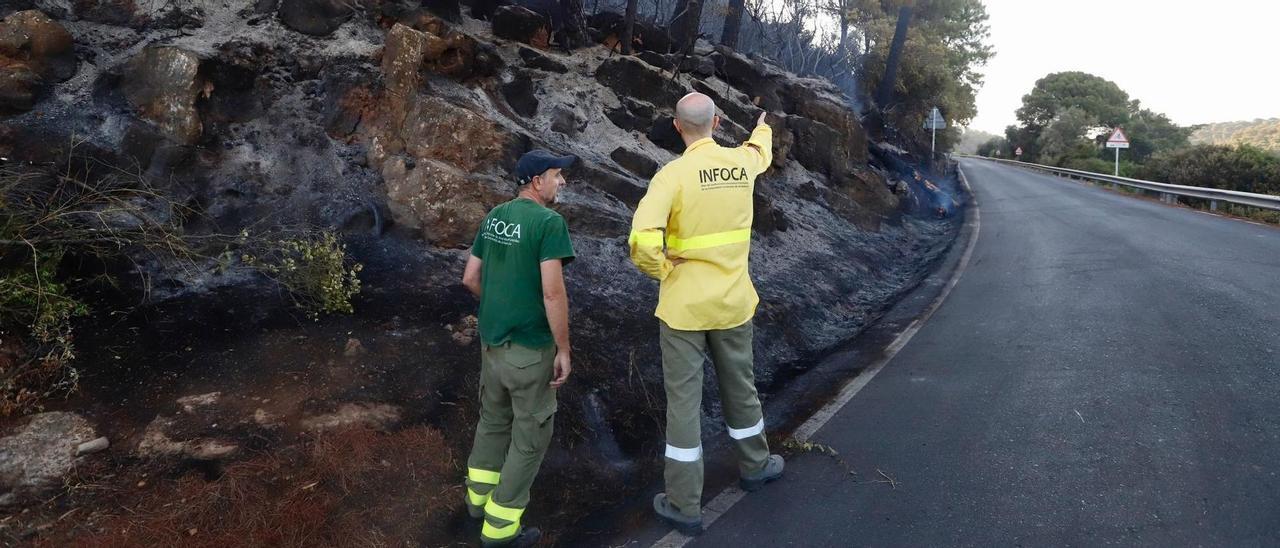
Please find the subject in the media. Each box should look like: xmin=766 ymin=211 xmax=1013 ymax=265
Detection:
xmin=630 ymin=93 xmax=783 ymax=534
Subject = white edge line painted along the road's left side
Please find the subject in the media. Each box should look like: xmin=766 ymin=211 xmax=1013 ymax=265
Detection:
xmin=653 ymin=168 xmax=982 ymax=548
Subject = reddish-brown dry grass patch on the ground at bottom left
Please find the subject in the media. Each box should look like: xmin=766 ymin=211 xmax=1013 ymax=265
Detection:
xmin=33 ymin=426 xmax=461 ymax=548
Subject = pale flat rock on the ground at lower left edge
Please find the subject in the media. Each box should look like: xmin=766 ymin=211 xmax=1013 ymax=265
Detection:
xmin=0 ymin=411 xmax=97 ymax=507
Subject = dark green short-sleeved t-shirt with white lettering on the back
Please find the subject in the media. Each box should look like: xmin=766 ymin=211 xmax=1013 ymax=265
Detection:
xmin=471 ymin=198 xmax=573 ymax=348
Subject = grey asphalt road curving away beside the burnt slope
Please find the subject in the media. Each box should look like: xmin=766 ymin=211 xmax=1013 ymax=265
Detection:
xmin=690 ymin=160 xmax=1280 ymax=547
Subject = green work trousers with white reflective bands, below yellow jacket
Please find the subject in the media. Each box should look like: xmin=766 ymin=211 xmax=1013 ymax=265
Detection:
xmin=660 ymin=321 xmax=769 ymax=516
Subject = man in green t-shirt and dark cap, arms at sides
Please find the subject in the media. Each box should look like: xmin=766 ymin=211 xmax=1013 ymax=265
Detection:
xmin=462 ymin=150 xmax=577 ymax=547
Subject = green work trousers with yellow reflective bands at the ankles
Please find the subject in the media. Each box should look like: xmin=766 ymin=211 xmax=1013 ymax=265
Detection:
xmin=466 ymin=343 xmax=556 ymax=540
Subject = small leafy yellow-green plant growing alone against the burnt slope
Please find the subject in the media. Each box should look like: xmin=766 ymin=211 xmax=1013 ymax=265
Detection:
xmin=241 ymin=232 xmax=364 ymax=320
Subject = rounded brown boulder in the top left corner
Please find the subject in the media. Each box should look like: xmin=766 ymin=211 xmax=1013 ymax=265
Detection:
xmin=0 ymin=10 xmax=77 ymax=113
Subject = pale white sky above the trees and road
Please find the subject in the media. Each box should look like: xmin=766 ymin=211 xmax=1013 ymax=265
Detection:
xmin=969 ymin=0 xmax=1280 ymax=134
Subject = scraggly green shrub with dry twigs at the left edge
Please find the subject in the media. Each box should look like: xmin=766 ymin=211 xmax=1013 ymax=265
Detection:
xmin=0 ymin=141 xmax=188 ymax=416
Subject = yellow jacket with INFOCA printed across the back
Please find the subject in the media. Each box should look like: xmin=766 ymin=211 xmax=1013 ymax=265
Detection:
xmin=628 ymin=124 xmax=773 ymax=330
